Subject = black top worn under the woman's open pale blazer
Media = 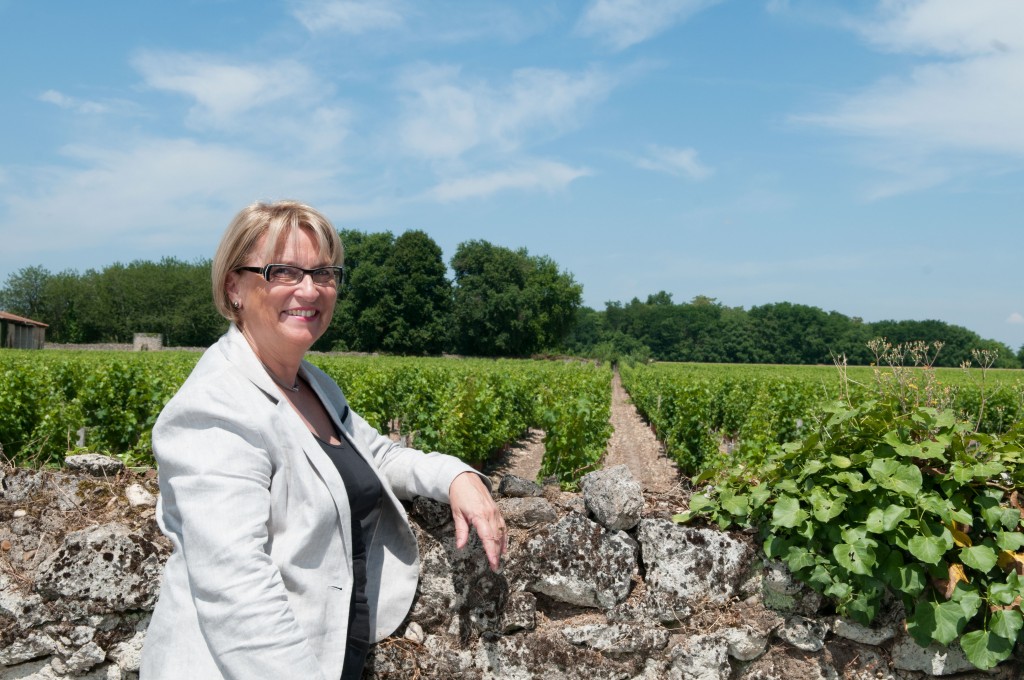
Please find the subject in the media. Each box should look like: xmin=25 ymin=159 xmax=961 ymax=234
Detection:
xmin=316 ymin=437 xmax=384 ymax=680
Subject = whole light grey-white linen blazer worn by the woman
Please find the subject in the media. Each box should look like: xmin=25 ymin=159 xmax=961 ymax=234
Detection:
xmin=140 ymin=325 xmax=489 ymax=680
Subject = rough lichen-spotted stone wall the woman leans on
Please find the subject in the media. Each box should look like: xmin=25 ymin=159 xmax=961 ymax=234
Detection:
xmin=0 ymin=457 xmax=1021 ymax=680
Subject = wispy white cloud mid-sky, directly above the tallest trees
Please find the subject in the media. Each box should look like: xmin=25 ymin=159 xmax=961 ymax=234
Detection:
xmin=399 ymin=66 xmax=613 ymax=159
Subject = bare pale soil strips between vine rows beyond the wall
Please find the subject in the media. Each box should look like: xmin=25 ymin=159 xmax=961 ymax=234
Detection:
xmin=487 ymin=373 xmax=680 ymax=494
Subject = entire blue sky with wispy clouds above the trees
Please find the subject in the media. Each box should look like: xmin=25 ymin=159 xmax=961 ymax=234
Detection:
xmin=0 ymin=0 xmax=1024 ymax=349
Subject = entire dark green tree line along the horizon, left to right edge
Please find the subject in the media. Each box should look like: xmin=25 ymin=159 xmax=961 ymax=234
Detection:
xmin=0 ymin=229 xmax=1024 ymax=368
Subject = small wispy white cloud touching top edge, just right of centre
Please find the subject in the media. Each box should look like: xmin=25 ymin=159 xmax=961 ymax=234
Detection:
xmin=577 ymin=0 xmax=720 ymax=50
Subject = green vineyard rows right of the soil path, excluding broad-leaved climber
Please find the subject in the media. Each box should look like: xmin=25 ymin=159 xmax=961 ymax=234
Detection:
xmin=621 ymin=356 xmax=1024 ymax=476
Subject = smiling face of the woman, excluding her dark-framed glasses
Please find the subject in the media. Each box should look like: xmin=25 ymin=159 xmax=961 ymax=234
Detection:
xmin=226 ymin=228 xmax=338 ymax=366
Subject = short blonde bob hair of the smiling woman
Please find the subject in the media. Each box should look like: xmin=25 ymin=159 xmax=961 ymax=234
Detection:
xmin=211 ymin=201 xmax=345 ymax=322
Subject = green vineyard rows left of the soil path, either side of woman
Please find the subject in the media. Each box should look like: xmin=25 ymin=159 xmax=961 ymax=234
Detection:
xmin=0 ymin=350 xmax=611 ymax=485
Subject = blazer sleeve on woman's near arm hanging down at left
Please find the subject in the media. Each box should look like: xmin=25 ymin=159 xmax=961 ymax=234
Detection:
xmin=153 ymin=390 xmax=324 ymax=680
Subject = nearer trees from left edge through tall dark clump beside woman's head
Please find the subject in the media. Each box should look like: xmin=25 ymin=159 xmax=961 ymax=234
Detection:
xmin=0 ymin=230 xmax=583 ymax=356
